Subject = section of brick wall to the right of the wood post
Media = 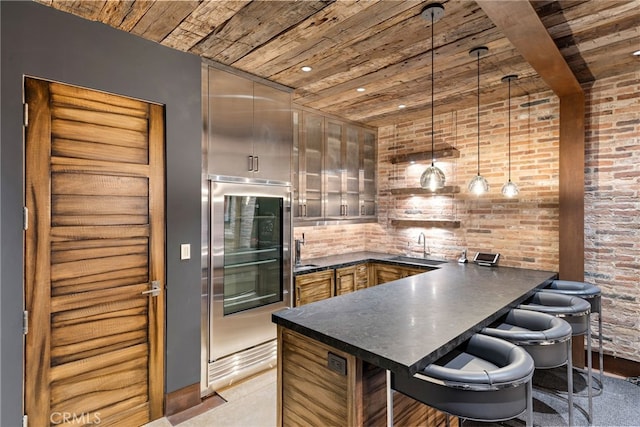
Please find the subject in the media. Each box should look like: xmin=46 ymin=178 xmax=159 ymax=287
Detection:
xmin=584 ymin=71 xmax=640 ymax=361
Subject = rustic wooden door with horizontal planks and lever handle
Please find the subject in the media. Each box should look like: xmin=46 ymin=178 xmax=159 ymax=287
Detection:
xmin=25 ymin=78 xmax=165 ymax=426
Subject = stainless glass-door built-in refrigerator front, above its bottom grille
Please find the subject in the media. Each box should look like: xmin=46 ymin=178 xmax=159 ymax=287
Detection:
xmin=208 ymin=176 xmax=291 ymax=386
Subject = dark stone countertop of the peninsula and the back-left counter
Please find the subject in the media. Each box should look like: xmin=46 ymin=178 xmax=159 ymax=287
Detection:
xmin=272 ymin=253 xmax=556 ymax=375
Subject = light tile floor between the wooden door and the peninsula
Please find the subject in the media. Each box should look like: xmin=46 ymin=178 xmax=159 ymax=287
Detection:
xmin=146 ymin=369 xmax=276 ymax=427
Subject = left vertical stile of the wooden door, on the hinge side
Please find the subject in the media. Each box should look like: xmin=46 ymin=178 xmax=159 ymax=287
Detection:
xmin=24 ymin=78 xmax=51 ymax=425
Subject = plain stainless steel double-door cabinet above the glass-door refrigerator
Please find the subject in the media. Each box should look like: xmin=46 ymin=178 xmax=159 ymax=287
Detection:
xmin=205 ymin=66 xmax=293 ymax=182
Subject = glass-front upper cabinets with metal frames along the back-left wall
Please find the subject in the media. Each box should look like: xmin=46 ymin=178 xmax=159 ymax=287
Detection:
xmin=293 ymin=110 xmax=377 ymax=222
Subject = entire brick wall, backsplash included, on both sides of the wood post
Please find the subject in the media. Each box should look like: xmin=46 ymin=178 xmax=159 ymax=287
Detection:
xmin=294 ymin=72 xmax=640 ymax=361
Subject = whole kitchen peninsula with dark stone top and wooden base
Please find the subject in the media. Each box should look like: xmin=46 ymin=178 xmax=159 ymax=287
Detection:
xmin=273 ymin=257 xmax=556 ymax=426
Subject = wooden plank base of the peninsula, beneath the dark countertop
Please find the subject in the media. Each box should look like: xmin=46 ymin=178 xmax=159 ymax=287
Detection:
xmin=277 ymin=326 xmax=458 ymax=427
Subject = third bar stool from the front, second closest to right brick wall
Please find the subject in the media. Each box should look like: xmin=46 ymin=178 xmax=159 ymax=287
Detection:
xmin=518 ymin=292 xmax=593 ymax=424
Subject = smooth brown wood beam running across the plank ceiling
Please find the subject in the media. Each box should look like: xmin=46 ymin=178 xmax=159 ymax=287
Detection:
xmin=476 ymin=0 xmax=583 ymax=97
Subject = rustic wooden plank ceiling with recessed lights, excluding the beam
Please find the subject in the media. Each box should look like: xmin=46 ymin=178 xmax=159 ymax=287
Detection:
xmin=37 ymin=0 xmax=640 ymax=126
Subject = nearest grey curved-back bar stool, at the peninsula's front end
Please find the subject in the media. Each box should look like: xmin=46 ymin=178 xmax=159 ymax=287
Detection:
xmin=391 ymin=334 xmax=534 ymax=426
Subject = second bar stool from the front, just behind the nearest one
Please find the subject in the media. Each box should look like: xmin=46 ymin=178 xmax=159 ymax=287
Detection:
xmin=481 ymin=308 xmax=573 ymax=425
